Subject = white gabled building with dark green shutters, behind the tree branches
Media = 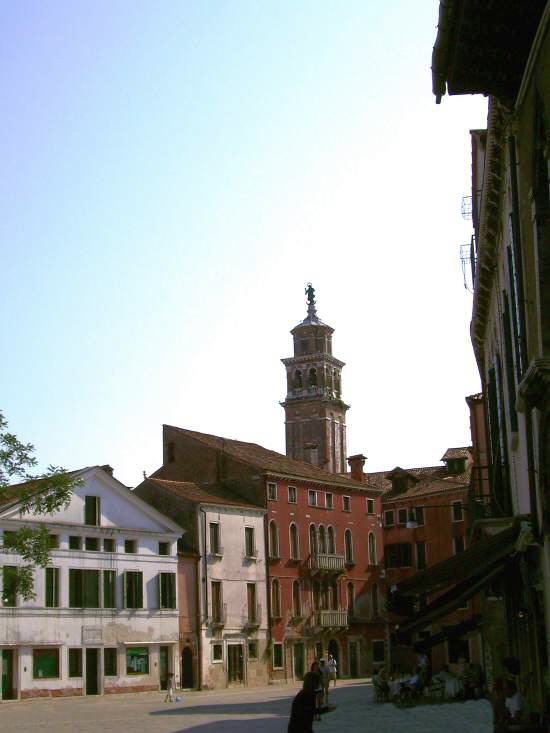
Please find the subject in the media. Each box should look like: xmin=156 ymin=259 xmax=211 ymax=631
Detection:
xmin=0 ymin=466 xmax=182 ymax=699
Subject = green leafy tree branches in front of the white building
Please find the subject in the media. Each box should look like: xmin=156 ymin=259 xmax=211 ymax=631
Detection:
xmin=0 ymin=412 xmax=82 ymax=600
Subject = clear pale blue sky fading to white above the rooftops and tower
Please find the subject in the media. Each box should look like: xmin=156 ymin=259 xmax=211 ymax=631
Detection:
xmin=0 ymin=0 xmax=486 ymax=485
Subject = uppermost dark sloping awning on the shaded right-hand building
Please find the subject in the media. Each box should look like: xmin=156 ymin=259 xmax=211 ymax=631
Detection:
xmin=396 ymin=524 xmax=520 ymax=596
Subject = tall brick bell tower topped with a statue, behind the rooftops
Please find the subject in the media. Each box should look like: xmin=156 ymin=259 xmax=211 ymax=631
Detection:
xmin=281 ymin=283 xmax=349 ymax=473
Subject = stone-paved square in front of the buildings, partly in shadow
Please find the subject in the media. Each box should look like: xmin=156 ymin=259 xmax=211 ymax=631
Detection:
xmin=0 ymin=681 xmax=492 ymax=733
